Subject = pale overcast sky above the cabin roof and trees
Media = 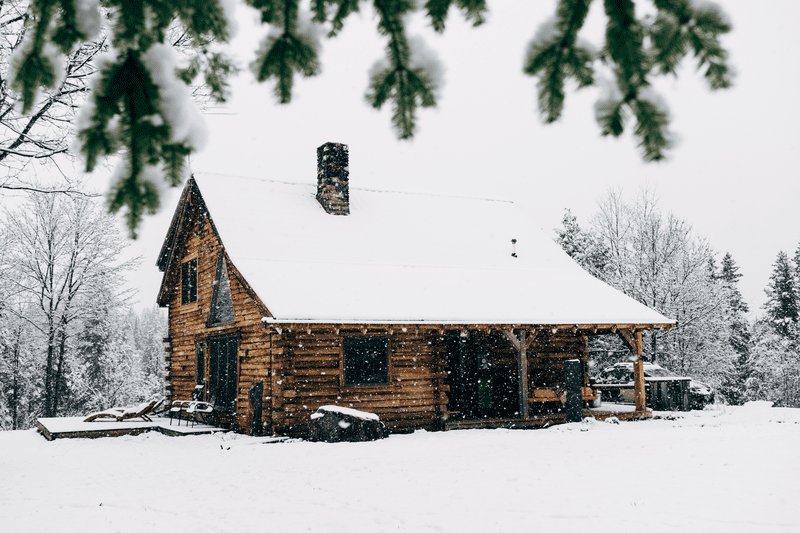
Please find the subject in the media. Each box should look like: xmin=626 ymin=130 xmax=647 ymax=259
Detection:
xmin=98 ymin=0 xmax=800 ymax=310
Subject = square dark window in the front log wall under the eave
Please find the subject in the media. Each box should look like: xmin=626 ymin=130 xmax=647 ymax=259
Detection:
xmin=344 ymin=336 xmax=389 ymax=386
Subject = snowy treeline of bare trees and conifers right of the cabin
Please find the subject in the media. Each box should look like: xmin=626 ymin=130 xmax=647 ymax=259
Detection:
xmin=555 ymin=189 xmax=800 ymax=407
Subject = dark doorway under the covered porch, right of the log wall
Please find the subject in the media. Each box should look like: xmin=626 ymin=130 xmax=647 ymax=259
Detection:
xmin=445 ymin=332 xmax=519 ymax=420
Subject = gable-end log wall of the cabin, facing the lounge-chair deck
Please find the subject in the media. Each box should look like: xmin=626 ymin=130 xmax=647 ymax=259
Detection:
xmin=166 ymin=197 xmax=272 ymax=432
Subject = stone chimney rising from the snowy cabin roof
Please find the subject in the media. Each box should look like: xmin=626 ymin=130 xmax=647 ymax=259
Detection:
xmin=317 ymin=143 xmax=350 ymax=215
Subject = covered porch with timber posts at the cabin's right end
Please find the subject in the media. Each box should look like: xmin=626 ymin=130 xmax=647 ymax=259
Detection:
xmin=443 ymin=325 xmax=652 ymax=430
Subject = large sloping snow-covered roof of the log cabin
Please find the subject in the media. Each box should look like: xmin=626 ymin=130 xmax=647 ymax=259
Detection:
xmin=178 ymin=174 xmax=673 ymax=325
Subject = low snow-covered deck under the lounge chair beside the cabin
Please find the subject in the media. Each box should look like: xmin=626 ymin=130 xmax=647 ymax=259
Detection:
xmin=36 ymin=416 xmax=226 ymax=440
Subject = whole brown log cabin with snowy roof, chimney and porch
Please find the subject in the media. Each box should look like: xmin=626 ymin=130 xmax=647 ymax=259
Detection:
xmin=157 ymin=143 xmax=674 ymax=436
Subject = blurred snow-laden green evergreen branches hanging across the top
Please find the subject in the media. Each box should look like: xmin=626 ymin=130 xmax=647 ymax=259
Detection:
xmin=4 ymin=0 xmax=731 ymax=235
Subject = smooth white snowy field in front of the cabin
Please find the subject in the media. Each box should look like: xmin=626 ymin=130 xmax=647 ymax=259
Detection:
xmin=0 ymin=404 xmax=800 ymax=533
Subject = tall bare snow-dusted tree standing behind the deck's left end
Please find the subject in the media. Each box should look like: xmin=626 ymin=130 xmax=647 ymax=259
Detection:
xmin=4 ymin=190 xmax=131 ymax=416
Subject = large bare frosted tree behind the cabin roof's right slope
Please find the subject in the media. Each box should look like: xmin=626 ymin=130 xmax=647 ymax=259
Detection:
xmin=590 ymin=189 xmax=734 ymax=381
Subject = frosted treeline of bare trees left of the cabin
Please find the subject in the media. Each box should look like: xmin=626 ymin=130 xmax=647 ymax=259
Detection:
xmin=0 ymin=193 xmax=166 ymax=429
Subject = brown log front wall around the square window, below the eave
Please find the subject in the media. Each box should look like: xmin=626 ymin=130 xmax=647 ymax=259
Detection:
xmin=270 ymin=324 xmax=449 ymax=436
